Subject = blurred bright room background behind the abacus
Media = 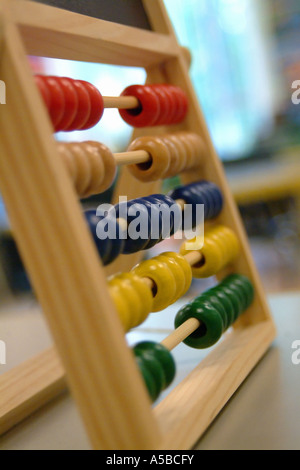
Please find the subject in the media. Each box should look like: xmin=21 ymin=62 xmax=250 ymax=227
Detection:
xmin=0 ymin=0 xmax=300 ymax=299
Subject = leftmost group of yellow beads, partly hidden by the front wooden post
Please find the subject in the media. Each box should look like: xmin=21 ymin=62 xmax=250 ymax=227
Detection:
xmin=109 ymin=273 xmax=153 ymax=331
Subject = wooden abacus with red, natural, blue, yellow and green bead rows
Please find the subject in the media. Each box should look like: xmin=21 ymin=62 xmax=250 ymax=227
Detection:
xmin=0 ymin=0 xmax=275 ymax=449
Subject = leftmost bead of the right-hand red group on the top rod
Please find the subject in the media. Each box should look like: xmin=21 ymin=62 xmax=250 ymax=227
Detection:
xmin=119 ymin=85 xmax=160 ymax=127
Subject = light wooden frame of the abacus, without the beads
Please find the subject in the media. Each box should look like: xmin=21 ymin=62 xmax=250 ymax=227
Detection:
xmin=0 ymin=0 xmax=275 ymax=449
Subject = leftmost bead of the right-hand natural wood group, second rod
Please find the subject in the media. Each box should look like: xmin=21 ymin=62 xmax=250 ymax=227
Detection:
xmin=127 ymin=136 xmax=171 ymax=182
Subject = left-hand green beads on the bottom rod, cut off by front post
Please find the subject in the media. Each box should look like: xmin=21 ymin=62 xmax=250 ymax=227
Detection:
xmin=133 ymin=341 xmax=176 ymax=402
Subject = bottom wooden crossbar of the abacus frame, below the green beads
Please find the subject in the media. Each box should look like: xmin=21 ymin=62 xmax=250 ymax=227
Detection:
xmin=154 ymin=321 xmax=275 ymax=450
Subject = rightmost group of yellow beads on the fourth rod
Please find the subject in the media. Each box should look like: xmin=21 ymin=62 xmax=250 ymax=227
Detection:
xmin=180 ymin=225 xmax=239 ymax=278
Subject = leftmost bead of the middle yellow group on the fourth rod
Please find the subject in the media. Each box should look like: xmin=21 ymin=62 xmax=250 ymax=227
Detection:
xmin=133 ymin=259 xmax=176 ymax=312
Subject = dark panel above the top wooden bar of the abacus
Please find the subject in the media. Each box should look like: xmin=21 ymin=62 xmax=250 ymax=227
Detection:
xmin=33 ymin=0 xmax=151 ymax=30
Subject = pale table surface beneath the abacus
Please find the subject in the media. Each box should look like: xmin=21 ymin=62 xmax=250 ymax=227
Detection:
xmin=0 ymin=292 xmax=300 ymax=450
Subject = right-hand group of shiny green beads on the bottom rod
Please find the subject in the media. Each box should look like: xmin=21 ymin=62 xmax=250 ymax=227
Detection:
xmin=175 ymin=274 xmax=254 ymax=349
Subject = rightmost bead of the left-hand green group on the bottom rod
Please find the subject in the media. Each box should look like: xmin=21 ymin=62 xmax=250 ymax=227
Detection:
xmin=134 ymin=341 xmax=176 ymax=388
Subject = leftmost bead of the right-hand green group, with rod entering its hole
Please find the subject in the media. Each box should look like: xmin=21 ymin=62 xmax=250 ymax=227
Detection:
xmin=175 ymin=298 xmax=223 ymax=349
